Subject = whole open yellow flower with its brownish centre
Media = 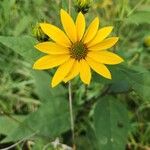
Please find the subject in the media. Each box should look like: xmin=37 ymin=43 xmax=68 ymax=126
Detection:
xmin=33 ymin=10 xmax=123 ymax=87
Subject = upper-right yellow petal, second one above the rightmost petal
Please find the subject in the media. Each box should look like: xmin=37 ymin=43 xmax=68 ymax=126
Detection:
xmin=87 ymin=26 xmax=113 ymax=47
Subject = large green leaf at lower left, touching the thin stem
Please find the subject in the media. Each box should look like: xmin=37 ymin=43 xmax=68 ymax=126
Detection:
xmin=4 ymin=97 xmax=70 ymax=142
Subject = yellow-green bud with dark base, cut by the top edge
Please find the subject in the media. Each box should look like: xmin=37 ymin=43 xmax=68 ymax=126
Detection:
xmin=75 ymin=0 xmax=93 ymax=14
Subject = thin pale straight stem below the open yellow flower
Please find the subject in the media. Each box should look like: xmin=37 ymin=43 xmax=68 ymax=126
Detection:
xmin=68 ymin=82 xmax=75 ymax=150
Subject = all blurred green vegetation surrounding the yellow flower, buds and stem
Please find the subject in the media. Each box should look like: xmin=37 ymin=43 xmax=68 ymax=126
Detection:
xmin=0 ymin=0 xmax=150 ymax=150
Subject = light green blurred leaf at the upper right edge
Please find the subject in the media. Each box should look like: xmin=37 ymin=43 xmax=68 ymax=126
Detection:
xmin=125 ymin=11 xmax=150 ymax=25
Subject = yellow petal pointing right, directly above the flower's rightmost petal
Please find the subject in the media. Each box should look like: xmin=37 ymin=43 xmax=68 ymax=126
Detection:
xmin=88 ymin=37 xmax=119 ymax=51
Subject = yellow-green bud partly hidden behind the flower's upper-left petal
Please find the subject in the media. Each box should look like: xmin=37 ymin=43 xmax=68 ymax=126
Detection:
xmin=32 ymin=23 xmax=49 ymax=42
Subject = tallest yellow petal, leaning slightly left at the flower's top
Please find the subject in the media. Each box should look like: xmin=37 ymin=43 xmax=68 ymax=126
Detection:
xmin=60 ymin=9 xmax=77 ymax=43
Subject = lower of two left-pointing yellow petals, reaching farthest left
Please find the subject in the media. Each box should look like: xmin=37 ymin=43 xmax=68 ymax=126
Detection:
xmin=33 ymin=54 xmax=70 ymax=70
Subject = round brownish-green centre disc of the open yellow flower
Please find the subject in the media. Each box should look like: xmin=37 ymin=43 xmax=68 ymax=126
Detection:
xmin=70 ymin=41 xmax=88 ymax=60
